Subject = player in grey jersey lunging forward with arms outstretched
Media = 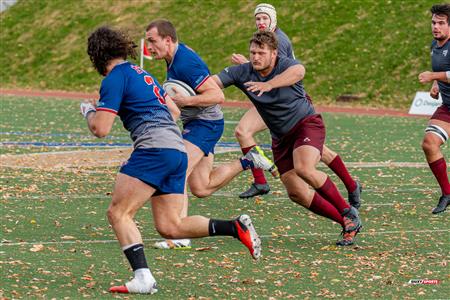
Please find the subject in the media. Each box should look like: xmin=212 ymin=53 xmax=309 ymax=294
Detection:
xmin=213 ymin=31 xmax=362 ymax=246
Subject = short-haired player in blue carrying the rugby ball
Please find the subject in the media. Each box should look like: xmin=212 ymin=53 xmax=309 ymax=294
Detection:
xmin=146 ymin=19 xmax=273 ymax=249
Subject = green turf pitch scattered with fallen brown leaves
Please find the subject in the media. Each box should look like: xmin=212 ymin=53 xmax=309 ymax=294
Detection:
xmin=0 ymin=96 xmax=450 ymax=299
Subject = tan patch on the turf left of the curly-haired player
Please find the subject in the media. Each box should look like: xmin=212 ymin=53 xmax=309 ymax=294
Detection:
xmin=0 ymin=148 xmax=132 ymax=171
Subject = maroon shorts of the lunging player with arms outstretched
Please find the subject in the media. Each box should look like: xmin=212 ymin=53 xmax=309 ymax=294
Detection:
xmin=272 ymin=114 xmax=325 ymax=175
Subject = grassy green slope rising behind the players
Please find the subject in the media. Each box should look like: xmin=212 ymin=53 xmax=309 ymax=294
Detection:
xmin=0 ymin=0 xmax=442 ymax=108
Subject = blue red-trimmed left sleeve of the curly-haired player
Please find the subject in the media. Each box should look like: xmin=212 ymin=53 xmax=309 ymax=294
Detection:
xmin=97 ymin=71 xmax=125 ymax=114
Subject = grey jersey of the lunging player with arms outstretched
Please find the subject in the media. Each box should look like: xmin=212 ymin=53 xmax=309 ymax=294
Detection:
xmin=217 ymin=57 xmax=315 ymax=139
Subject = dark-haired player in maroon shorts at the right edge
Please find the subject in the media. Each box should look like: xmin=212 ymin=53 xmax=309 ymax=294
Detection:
xmin=419 ymin=4 xmax=450 ymax=214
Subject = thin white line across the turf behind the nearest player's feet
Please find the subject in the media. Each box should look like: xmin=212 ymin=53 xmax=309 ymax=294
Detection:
xmin=0 ymin=229 xmax=450 ymax=247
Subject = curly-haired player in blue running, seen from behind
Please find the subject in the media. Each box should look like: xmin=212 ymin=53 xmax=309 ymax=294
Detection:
xmin=80 ymin=27 xmax=261 ymax=294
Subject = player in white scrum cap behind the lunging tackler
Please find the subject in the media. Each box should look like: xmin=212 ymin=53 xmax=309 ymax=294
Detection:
xmin=231 ymin=3 xmax=362 ymax=208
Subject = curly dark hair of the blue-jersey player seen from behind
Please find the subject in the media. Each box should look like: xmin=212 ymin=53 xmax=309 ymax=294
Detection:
xmin=87 ymin=26 xmax=137 ymax=76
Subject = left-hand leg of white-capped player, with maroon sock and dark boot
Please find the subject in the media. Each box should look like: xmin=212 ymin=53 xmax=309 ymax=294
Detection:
xmin=234 ymin=107 xmax=270 ymax=198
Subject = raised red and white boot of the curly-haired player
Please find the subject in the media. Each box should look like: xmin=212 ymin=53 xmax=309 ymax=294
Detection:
xmin=234 ymin=215 xmax=261 ymax=260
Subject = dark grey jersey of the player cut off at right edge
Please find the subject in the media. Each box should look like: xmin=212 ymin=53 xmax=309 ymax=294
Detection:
xmin=431 ymin=40 xmax=450 ymax=109
